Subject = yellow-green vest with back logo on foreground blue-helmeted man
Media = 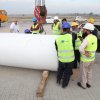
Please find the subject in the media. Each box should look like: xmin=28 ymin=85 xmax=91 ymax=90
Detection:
xmin=56 ymin=34 xmax=75 ymax=62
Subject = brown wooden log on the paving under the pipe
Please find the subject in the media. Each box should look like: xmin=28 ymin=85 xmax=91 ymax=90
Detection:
xmin=36 ymin=71 xmax=49 ymax=97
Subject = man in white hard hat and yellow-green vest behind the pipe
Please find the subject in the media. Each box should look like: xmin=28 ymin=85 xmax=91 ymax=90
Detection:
xmin=52 ymin=16 xmax=62 ymax=35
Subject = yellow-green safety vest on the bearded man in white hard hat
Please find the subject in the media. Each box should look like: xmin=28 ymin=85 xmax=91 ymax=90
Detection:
xmin=81 ymin=35 xmax=97 ymax=62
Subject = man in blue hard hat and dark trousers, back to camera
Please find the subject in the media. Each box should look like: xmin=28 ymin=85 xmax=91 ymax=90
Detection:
xmin=55 ymin=22 xmax=75 ymax=88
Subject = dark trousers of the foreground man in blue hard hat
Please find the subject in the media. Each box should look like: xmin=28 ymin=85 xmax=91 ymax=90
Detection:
xmin=57 ymin=61 xmax=73 ymax=88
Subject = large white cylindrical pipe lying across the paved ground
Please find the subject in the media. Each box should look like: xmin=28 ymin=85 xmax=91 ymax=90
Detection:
xmin=0 ymin=33 xmax=58 ymax=71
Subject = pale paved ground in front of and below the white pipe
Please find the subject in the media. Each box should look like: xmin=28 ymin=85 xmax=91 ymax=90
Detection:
xmin=0 ymin=54 xmax=100 ymax=100
